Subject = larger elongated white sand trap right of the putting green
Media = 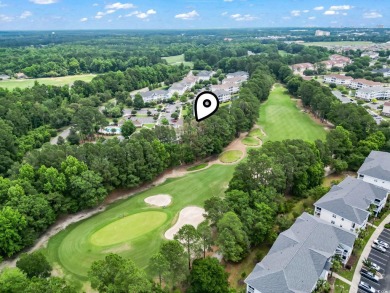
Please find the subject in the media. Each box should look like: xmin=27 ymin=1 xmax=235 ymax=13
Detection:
xmin=164 ymin=207 xmax=205 ymax=240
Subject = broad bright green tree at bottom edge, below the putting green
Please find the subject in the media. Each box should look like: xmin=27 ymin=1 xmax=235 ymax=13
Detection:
xmin=88 ymin=253 xmax=151 ymax=292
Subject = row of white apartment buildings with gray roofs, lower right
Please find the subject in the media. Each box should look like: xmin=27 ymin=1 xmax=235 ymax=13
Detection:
xmin=245 ymin=151 xmax=390 ymax=293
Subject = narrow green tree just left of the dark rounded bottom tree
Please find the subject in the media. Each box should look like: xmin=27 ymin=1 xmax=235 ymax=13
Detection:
xmin=160 ymin=240 xmax=188 ymax=287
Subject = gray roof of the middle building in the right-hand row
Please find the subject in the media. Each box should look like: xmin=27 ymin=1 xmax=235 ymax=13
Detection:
xmin=314 ymin=177 xmax=387 ymax=225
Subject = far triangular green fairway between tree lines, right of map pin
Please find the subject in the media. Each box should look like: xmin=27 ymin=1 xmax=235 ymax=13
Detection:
xmin=258 ymin=86 xmax=326 ymax=141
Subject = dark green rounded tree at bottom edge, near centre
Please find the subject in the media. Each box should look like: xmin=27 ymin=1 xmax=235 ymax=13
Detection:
xmin=187 ymin=257 xmax=229 ymax=293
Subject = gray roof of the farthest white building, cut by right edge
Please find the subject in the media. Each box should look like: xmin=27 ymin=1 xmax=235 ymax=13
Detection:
xmin=358 ymin=151 xmax=390 ymax=181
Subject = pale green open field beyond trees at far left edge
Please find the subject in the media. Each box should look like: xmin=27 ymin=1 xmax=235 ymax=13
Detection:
xmin=0 ymin=74 xmax=96 ymax=89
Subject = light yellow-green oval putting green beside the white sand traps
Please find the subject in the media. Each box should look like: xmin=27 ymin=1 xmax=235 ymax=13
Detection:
xmin=90 ymin=211 xmax=168 ymax=246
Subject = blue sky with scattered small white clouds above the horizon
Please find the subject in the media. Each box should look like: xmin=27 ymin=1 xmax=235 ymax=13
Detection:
xmin=0 ymin=0 xmax=390 ymax=31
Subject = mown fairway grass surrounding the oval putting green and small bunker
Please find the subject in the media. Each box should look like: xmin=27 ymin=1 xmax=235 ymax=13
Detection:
xmin=45 ymin=165 xmax=235 ymax=282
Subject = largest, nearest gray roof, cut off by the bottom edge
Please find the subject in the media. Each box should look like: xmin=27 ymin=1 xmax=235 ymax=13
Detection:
xmin=245 ymin=213 xmax=356 ymax=293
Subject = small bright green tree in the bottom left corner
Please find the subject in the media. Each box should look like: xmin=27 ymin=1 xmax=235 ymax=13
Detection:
xmin=0 ymin=268 xmax=28 ymax=293
